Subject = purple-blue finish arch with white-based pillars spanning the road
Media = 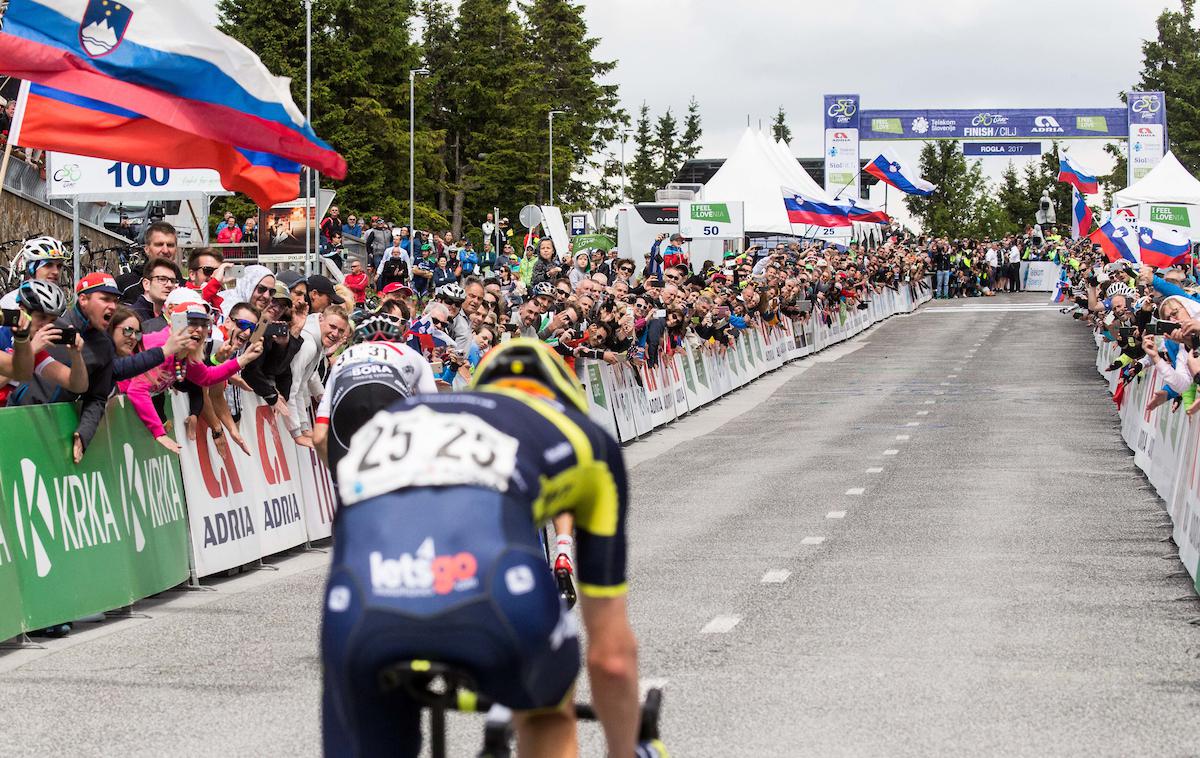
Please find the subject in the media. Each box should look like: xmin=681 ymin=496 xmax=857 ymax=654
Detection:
xmin=824 ymin=92 xmax=1166 ymax=198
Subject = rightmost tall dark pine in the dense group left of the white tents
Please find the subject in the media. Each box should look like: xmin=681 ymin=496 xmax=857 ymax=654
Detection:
xmin=521 ymin=0 xmax=623 ymax=206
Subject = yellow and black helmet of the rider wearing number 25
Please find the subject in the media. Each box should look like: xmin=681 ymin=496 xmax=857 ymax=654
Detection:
xmin=470 ymin=337 xmax=588 ymax=414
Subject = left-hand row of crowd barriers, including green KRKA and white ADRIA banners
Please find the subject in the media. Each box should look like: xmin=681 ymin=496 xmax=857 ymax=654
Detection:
xmin=0 ymin=283 xmax=931 ymax=640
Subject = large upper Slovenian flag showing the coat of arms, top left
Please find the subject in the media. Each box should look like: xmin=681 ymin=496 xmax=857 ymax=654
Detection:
xmin=0 ymin=0 xmax=346 ymax=179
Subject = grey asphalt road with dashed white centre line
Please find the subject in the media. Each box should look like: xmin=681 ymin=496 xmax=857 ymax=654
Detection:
xmin=0 ymin=294 xmax=1200 ymax=758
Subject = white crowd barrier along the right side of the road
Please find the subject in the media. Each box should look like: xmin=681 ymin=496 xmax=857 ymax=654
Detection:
xmin=1096 ymin=335 xmax=1200 ymax=592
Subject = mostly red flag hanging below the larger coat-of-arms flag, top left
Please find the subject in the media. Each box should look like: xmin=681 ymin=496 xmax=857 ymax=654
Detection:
xmin=12 ymin=82 xmax=300 ymax=207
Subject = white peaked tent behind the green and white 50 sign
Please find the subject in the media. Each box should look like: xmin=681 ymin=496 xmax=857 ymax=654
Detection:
xmin=703 ymin=127 xmax=793 ymax=234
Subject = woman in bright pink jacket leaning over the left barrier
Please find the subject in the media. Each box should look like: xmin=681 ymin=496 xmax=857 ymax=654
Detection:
xmin=118 ymin=297 xmax=263 ymax=453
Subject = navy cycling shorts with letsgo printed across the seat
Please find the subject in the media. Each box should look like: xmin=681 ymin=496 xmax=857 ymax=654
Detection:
xmin=320 ymin=487 xmax=580 ymax=756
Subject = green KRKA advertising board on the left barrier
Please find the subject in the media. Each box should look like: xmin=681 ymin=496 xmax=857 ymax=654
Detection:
xmin=0 ymin=399 xmax=188 ymax=638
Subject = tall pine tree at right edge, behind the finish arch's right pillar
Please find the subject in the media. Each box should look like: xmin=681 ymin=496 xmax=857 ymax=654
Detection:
xmin=1138 ymin=0 xmax=1200 ymax=173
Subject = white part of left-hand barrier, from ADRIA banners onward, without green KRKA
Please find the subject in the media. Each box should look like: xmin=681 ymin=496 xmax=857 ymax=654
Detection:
xmin=159 ymin=283 xmax=932 ymax=582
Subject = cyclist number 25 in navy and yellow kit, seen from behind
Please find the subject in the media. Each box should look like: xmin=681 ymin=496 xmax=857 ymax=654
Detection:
xmin=322 ymin=339 xmax=638 ymax=757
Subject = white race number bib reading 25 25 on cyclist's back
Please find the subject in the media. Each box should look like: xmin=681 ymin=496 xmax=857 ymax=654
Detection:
xmin=337 ymin=407 xmax=518 ymax=505
